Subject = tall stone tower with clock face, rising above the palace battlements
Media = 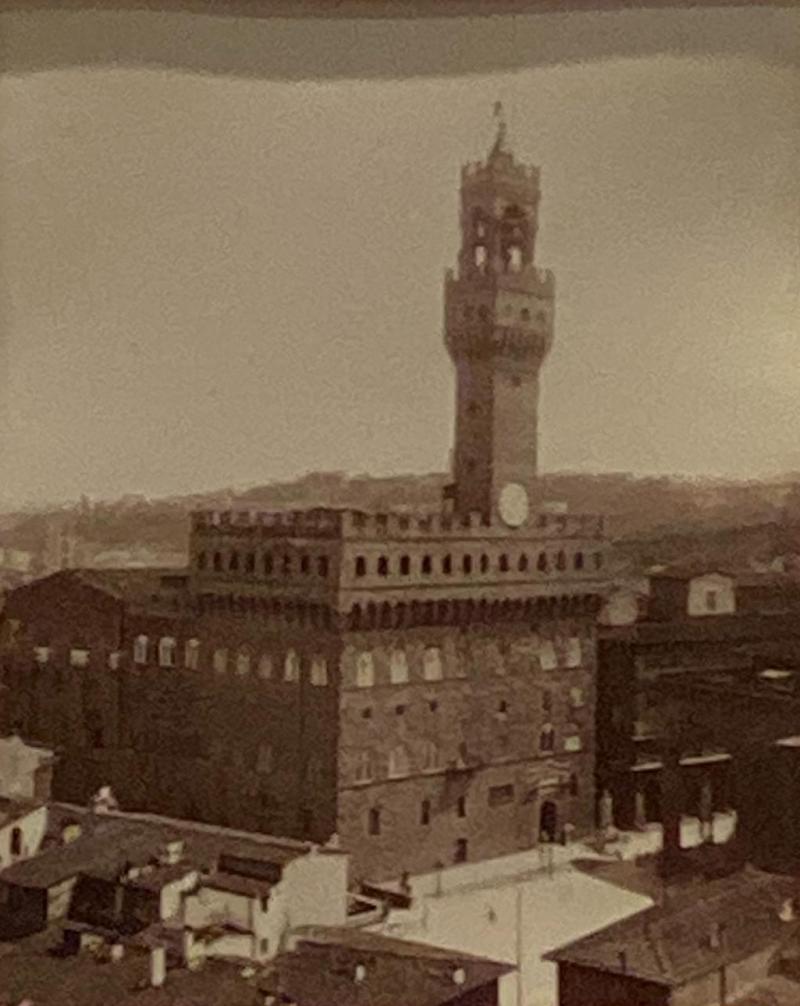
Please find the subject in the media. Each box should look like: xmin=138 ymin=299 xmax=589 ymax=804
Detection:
xmin=445 ymin=104 xmax=554 ymax=526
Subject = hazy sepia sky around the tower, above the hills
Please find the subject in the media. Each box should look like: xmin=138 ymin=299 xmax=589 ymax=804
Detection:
xmin=0 ymin=3 xmax=800 ymax=500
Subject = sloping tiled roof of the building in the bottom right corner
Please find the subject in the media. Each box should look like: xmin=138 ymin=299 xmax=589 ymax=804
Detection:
xmin=544 ymin=868 xmax=800 ymax=986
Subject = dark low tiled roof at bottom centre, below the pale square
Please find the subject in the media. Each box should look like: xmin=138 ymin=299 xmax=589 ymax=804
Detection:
xmin=259 ymin=927 xmax=513 ymax=1006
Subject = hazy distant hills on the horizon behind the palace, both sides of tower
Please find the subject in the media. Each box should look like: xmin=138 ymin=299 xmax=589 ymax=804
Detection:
xmin=0 ymin=472 xmax=800 ymax=579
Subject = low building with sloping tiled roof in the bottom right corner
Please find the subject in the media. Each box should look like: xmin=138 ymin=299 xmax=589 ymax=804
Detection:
xmin=545 ymin=869 xmax=800 ymax=1006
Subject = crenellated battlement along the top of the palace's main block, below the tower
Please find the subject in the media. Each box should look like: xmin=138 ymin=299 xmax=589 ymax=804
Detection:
xmin=191 ymin=508 xmax=605 ymax=541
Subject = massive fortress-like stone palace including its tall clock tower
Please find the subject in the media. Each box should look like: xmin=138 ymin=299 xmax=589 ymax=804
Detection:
xmin=0 ymin=115 xmax=610 ymax=879
